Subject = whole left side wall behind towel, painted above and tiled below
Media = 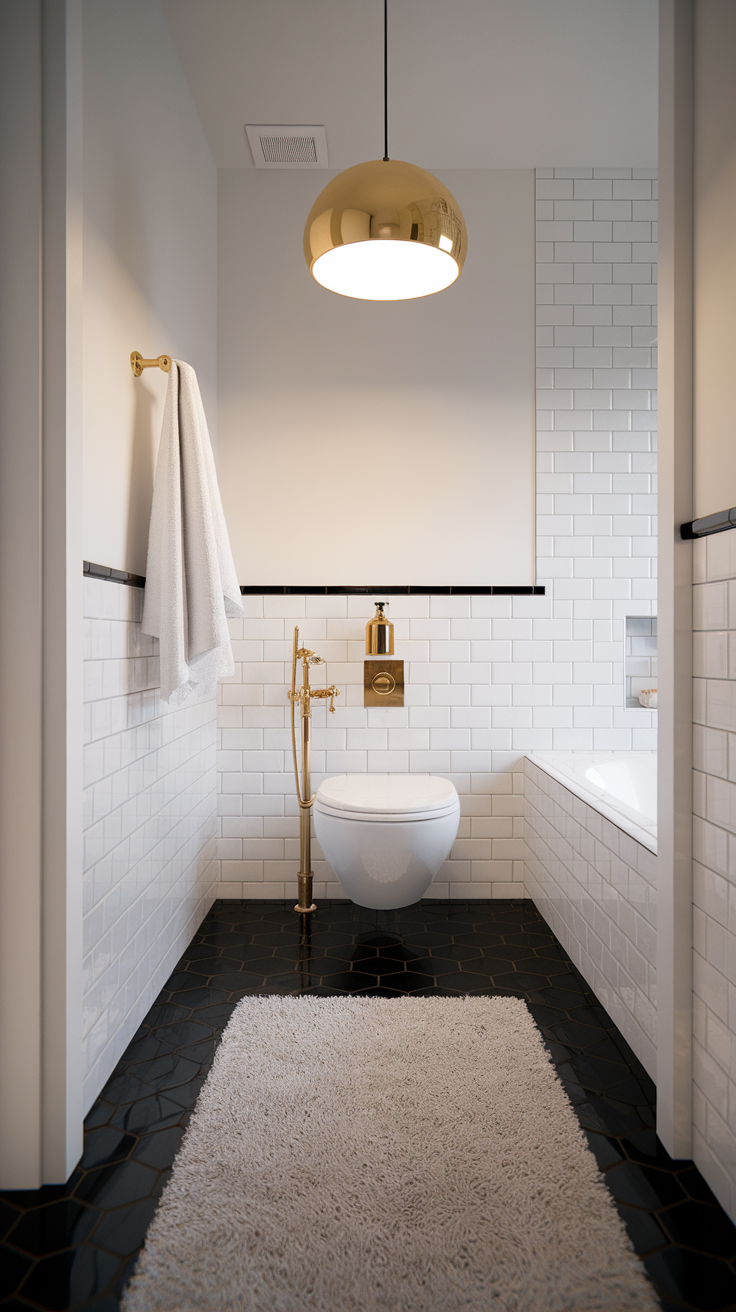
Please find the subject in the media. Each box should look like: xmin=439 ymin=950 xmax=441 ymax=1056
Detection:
xmin=77 ymin=0 xmax=223 ymax=1109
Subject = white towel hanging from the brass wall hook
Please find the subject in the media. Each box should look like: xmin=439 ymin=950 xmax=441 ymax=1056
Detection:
xmin=142 ymin=359 xmax=243 ymax=706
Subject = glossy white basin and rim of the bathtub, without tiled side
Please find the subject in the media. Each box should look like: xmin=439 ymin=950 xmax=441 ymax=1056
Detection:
xmin=527 ymin=752 xmax=657 ymax=853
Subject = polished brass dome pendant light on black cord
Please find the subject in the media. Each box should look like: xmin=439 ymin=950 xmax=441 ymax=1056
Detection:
xmin=304 ymin=0 xmax=467 ymax=300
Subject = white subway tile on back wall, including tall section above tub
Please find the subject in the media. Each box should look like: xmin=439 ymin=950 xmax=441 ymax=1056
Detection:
xmin=218 ymin=168 xmax=656 ymax=897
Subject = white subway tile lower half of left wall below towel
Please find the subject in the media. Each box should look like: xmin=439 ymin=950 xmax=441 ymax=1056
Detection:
xmin=83 ymin=579 xmax=219 ymax=1111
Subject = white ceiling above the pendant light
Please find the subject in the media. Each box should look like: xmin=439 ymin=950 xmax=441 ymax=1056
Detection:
xmin=163 ymin=0 xmax=659 ymax=168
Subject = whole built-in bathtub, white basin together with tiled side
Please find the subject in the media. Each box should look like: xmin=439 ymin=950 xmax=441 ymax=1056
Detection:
xmin=523 ymin=752 xmax=657 ymax=1081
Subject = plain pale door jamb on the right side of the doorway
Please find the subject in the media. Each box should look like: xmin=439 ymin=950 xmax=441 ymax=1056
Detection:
xmin=657 ymin=0 xmax=693 ymax=1175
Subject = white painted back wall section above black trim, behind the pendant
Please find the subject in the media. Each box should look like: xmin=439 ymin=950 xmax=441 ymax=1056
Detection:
xmin=218 ymin=169 xmax=534 ymax=585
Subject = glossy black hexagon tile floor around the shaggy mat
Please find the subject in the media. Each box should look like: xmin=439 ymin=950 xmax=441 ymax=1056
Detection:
xmin=0 ymin=901 xmax=736 ymax=1312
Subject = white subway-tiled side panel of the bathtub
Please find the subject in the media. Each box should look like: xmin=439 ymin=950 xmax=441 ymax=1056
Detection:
xmin=523 ymin=760 xmax=657 ymax=1078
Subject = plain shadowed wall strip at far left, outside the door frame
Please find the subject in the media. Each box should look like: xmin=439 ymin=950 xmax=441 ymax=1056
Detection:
xmin=0 ymin=0 xmax=43 ymax=1189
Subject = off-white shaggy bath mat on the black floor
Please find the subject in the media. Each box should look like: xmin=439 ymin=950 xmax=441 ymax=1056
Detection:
xmin=122 ymin=997 xmax=659 ymax=1312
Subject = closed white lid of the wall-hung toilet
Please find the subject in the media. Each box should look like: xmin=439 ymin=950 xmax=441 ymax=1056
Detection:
xmin=317 ymin=774 xmax=458 ymax=815
